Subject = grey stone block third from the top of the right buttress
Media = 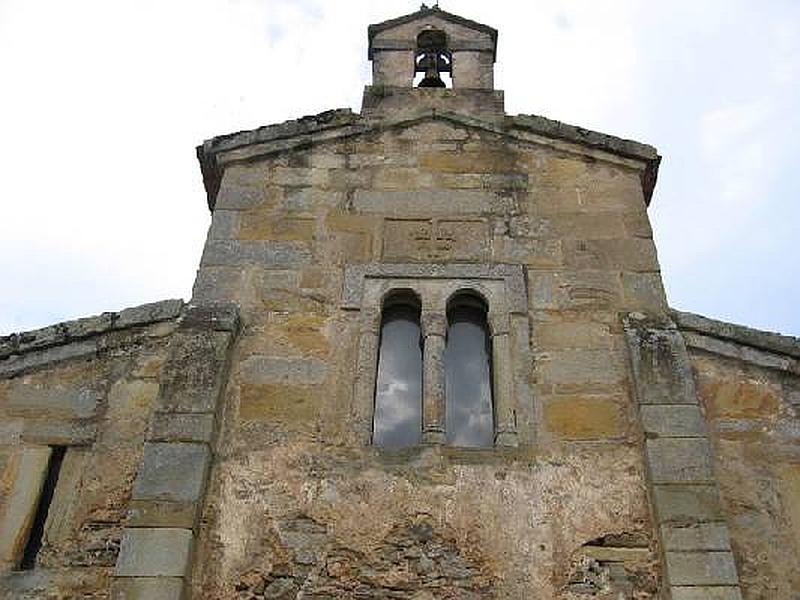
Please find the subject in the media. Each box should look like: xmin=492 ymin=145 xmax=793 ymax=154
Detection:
xmin=645 ymin=438 xmax=714 ymax=483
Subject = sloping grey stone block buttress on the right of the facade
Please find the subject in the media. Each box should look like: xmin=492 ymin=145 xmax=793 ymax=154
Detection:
xmin=625 ymin=315 xmax=741 ymax=600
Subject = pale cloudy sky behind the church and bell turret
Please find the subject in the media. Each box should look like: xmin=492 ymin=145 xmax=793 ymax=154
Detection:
xmin=0 ymin=0 xmax=800 ymax=335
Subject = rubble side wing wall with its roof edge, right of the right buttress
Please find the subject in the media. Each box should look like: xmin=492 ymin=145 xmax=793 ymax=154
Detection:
xmin=675 ymin=313 xmax=800 ymax=600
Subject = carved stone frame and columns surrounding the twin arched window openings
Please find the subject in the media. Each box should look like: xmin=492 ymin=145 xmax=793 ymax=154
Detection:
xmin=341 ymin=263 xmax=534 ymax=448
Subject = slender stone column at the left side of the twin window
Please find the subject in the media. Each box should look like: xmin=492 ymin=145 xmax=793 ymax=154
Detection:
xmin=352 ymin=309 xmax=381 ymax=445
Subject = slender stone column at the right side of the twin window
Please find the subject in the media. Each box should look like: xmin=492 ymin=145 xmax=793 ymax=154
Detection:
xmin=489 ymin=314 xmax=518 ymax=447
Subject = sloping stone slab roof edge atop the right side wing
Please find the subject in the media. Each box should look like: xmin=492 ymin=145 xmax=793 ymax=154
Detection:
xmin=670 ymin=309 xmax=800 ymax=359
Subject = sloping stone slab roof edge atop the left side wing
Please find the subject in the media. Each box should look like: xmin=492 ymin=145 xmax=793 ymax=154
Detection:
xmin=0 ymin=299 xmax=185 ymax=361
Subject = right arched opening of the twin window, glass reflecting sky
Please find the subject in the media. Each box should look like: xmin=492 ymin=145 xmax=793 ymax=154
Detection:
xmin=445 ymin=293 xmax=494 ymax=447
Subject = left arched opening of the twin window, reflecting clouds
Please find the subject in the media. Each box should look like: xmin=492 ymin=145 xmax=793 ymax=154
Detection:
xmin=372 ymin=291 xmax=422 ymax=447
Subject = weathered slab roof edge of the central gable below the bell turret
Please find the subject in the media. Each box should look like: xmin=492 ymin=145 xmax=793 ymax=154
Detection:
xmin=197 ymin=108 xmax=661 ymax=212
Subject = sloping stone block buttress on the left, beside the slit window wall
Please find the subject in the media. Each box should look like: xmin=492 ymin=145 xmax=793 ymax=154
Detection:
xmin=111 ymin=306 xmax=239 ymax=600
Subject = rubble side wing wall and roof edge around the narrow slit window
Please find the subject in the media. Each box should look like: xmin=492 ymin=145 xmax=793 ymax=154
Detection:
xmin=0 ymin=300 xmax=183 ymax=600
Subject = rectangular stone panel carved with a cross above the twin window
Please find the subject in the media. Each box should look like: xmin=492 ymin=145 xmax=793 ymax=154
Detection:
xmin=383 ymin=219 xmax=489 ymax=262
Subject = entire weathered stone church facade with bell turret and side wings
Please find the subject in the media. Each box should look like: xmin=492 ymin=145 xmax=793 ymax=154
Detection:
xmin=0 ymin=7 xmax=800 ymax=600
